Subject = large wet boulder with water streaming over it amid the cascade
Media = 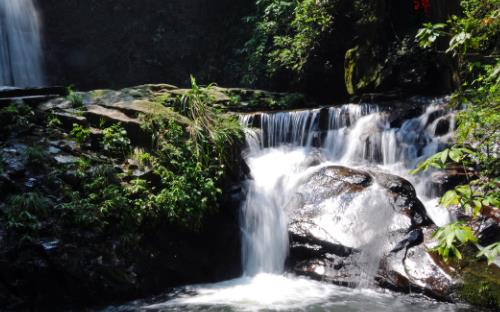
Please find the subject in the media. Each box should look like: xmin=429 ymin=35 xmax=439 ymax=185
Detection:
xmin=287 ymin=166 xmax=457 ymax=299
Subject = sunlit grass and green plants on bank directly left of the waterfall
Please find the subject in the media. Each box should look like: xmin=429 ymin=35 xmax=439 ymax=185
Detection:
xmin=138 ymin=78 xmax=242 ymax=228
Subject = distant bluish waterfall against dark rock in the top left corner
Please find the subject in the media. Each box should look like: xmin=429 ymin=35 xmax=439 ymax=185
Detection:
xmin=0 ymin=0 xmax=44 ymax=87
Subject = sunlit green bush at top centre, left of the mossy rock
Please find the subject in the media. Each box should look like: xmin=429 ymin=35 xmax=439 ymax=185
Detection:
xmin=242 ymin=0 xmax=337 ymax=85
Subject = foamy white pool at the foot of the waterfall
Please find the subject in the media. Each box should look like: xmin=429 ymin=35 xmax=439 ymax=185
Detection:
xmin=103 ymin=274 xmax=478 ymax=312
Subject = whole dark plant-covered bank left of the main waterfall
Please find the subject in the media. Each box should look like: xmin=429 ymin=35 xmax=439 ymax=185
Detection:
xmin=0 ymin=78 xmax=242 ymax=308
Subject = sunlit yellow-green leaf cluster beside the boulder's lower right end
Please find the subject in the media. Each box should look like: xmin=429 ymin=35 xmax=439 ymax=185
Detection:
xmin=433 ymin=222 xmax=477 ymax=262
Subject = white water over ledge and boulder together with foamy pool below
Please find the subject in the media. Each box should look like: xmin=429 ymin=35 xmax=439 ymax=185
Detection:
xmin=108 ymin=99 xmax=469 ymax=311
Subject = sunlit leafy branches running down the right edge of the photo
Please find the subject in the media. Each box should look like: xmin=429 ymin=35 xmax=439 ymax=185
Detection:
xmin=417 ymin=0 xmax=500 ymax=306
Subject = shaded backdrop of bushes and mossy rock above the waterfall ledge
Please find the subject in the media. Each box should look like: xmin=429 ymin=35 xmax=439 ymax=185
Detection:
xmin=241 ymin=0 xmax=454 ymax=101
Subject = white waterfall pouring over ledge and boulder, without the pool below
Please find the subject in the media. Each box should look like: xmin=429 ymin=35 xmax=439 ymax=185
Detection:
xmin=240 ymin=99 xmax=454 ymax=278
